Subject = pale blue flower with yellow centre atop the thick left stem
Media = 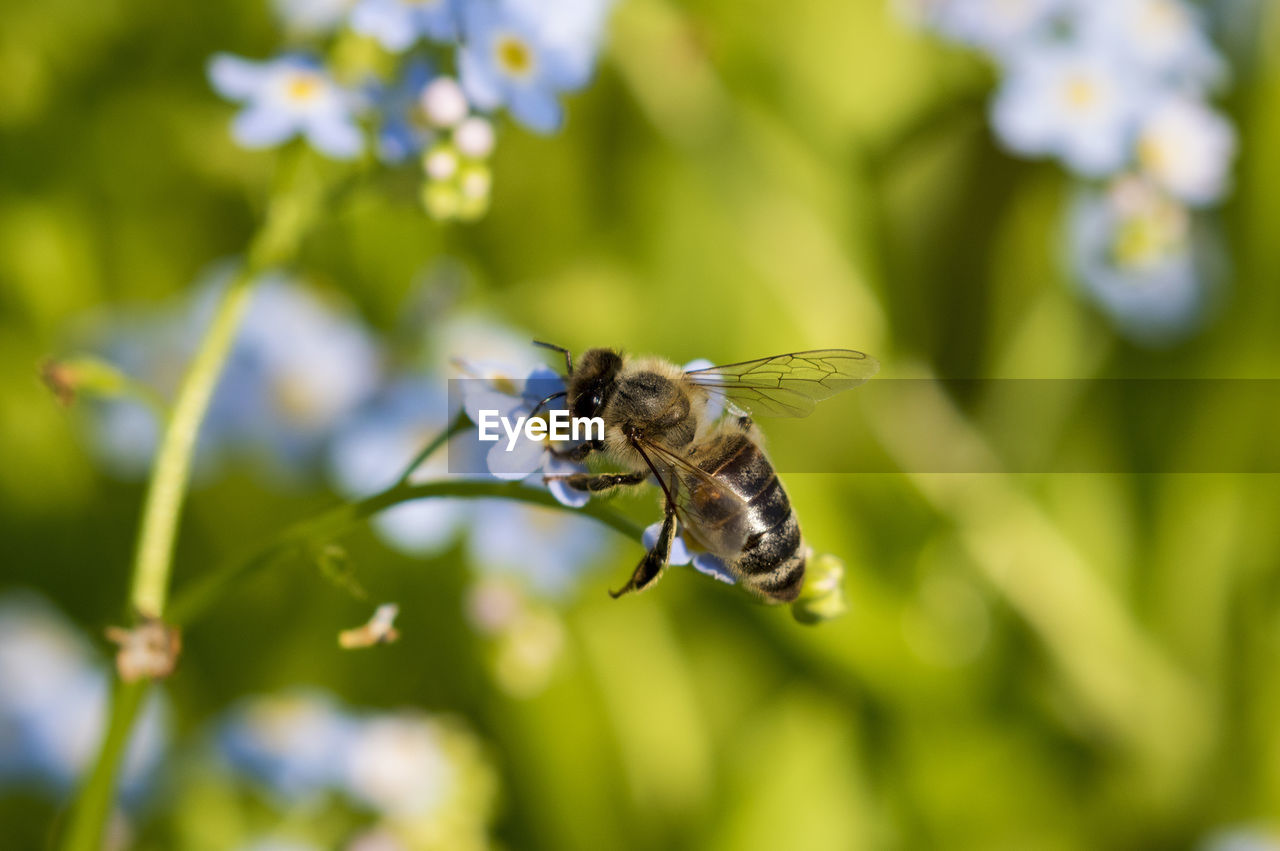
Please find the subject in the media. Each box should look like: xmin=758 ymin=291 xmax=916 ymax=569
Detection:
xmin=209 ymin=54 xmax=364 ymax=160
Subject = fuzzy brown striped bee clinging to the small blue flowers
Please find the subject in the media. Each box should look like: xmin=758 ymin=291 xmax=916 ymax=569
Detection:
xmin=536 ymin=342 xmax=879 ymax=603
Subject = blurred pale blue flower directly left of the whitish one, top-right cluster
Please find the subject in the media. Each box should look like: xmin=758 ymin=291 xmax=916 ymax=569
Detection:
xmin=991 ymin=45 xmax=1147 ymax=177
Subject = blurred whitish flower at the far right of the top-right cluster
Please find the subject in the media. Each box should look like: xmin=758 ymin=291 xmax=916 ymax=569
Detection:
xmin=1138 ymin=95 xmax=1235 ymax=206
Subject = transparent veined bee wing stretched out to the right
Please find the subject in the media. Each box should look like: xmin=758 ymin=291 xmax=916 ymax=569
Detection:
xmin=685 ymin=348 xmax=879 ymax=417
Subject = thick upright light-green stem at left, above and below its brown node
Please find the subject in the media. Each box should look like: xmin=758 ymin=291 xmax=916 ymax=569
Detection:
xmin=63 ymin=146 xmax=325 ymax=851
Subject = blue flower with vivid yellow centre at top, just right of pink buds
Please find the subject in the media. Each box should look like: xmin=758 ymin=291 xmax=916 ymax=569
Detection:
xmin=458 ymin=0 xmax=608 ymax=133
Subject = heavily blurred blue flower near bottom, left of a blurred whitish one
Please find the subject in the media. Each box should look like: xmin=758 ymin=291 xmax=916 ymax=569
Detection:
xmin=218 ymin=692 xmax=356 ymax=802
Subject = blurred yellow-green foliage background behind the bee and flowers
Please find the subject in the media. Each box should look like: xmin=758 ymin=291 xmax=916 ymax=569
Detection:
xmin=0 ymin=0 xmax=1280 ymax=850
